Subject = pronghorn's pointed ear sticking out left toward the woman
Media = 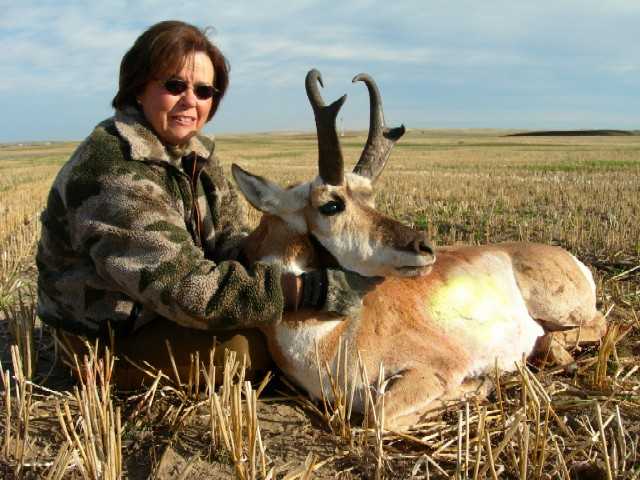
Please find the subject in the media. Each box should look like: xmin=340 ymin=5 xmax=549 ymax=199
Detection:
xmin=231 ymin=163 xmax=306 ymax=216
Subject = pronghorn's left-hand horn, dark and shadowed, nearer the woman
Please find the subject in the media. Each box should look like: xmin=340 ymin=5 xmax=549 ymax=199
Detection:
xmin=305 ymin=69 xmax=347 ymax=185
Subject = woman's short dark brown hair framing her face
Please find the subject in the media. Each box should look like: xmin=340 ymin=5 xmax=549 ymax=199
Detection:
xmin=111 ymin=20 xmax=229 ymax=121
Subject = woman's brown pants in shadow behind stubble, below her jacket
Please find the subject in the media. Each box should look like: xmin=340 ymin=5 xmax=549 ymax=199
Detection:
xmin=56 ymin=318 xmax=273 ymax=390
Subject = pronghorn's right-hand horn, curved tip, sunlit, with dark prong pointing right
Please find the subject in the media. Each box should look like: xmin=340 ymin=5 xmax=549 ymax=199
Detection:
xmin=352 ymin=73 xmax=405 ymax=182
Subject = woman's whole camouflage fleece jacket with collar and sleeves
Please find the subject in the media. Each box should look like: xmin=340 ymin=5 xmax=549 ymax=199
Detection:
xmin=36 ymin=110 xmax=283 ymax=336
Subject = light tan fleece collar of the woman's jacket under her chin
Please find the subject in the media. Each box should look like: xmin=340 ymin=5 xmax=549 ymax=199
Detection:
xmin=114 ymin=107 xmax=213 ymax=165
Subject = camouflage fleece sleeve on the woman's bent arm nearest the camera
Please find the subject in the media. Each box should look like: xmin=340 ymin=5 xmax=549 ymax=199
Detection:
xmin=66 ymin=144 xmax=283 ymax=329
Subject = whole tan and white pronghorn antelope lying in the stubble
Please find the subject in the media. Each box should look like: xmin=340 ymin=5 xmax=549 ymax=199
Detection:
xmin=232 ymin=70 xmax=605 ymax=427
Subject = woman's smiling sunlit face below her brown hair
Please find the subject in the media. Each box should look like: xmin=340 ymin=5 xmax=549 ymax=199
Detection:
xmin=138 ymin=52 xmax=214 ymax=145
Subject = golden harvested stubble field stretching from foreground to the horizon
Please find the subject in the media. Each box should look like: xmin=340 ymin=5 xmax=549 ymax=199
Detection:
xmin=0 ymin=130 xmax=640 ymax=479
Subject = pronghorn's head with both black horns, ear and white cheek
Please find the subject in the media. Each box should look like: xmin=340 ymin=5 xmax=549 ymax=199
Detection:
xmin=232 ymin=70 xmax=435 ymax=277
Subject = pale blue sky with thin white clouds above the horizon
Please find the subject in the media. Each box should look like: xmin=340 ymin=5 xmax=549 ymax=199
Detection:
xmin=0 ymin=0 xmax=640 ymax=142
